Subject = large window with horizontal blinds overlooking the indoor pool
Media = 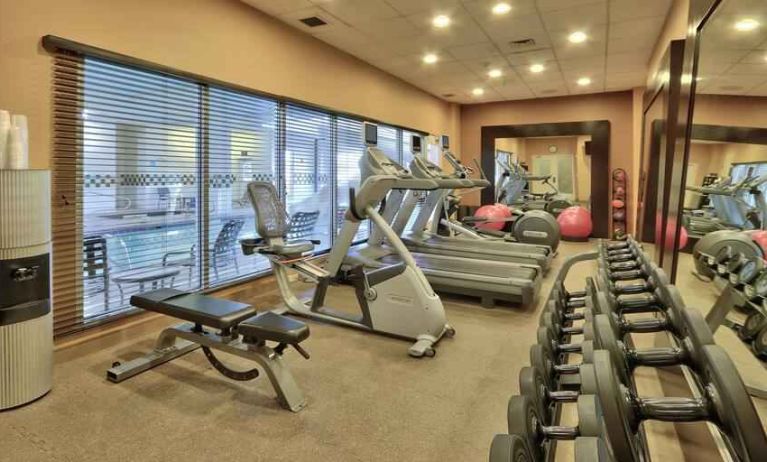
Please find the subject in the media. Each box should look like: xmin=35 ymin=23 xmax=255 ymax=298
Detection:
xmin=53 ymin=55 xmax=426 ymax=334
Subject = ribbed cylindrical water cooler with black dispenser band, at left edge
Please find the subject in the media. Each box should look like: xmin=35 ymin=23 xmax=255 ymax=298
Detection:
xmin=0 ymin=170 xmax=53 ymax=410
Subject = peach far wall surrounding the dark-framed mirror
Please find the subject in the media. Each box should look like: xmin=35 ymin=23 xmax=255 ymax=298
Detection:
xmin=461 ymin=91 xmax=636 ymax=226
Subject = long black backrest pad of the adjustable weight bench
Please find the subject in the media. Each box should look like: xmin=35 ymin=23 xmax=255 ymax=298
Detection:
xmin=130 ymin=289 xmax=257 ymax=330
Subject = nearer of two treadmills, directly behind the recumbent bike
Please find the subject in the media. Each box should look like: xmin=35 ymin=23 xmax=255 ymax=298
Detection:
xmin=344 ymin=129 xmax=543 ymax=307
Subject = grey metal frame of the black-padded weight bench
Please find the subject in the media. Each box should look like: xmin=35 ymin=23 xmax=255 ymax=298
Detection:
xmin=107 ymin=322 xmax=306 ymax=412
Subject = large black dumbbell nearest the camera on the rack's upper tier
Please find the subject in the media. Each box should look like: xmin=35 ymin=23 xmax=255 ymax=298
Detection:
xmin=593 ymin=345 xmax=767 ymax=462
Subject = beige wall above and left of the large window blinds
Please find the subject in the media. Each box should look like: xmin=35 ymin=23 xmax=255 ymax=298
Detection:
xmin=0 ymin=0 xmax=460 ymax=167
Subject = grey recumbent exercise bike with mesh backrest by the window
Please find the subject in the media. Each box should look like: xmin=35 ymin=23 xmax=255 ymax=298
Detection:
xmin=241 ymin=124 xmax=455 ymax=357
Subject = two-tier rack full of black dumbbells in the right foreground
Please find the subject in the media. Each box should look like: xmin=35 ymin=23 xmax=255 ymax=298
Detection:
xmin=491 ymin=237 xmax=767 ymax=462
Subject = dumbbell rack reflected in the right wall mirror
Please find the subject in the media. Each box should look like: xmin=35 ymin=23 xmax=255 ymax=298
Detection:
xmin=699 ymin=252 xmax=767 ymax=399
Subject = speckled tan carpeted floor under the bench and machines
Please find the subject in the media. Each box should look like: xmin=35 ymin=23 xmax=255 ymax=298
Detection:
xmin=0 ymin=243 xmax=760 ymax=462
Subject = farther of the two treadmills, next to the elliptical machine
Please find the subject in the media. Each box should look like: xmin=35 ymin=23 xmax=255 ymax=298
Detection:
xmin=388 ymin=135 xmax=554 ymax=273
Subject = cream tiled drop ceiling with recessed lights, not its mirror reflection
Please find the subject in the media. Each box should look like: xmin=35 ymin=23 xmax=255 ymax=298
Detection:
xmin=242 ymin=0 xmax=671 ymax=103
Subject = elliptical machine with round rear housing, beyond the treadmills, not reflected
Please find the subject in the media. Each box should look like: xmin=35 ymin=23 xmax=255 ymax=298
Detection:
xmin=432 ymin=135 xmax=560 ymax=251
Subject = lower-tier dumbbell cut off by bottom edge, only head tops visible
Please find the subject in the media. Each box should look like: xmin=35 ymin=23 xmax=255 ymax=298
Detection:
xmin=490 ymin=434 xmax=614 ymax=462
